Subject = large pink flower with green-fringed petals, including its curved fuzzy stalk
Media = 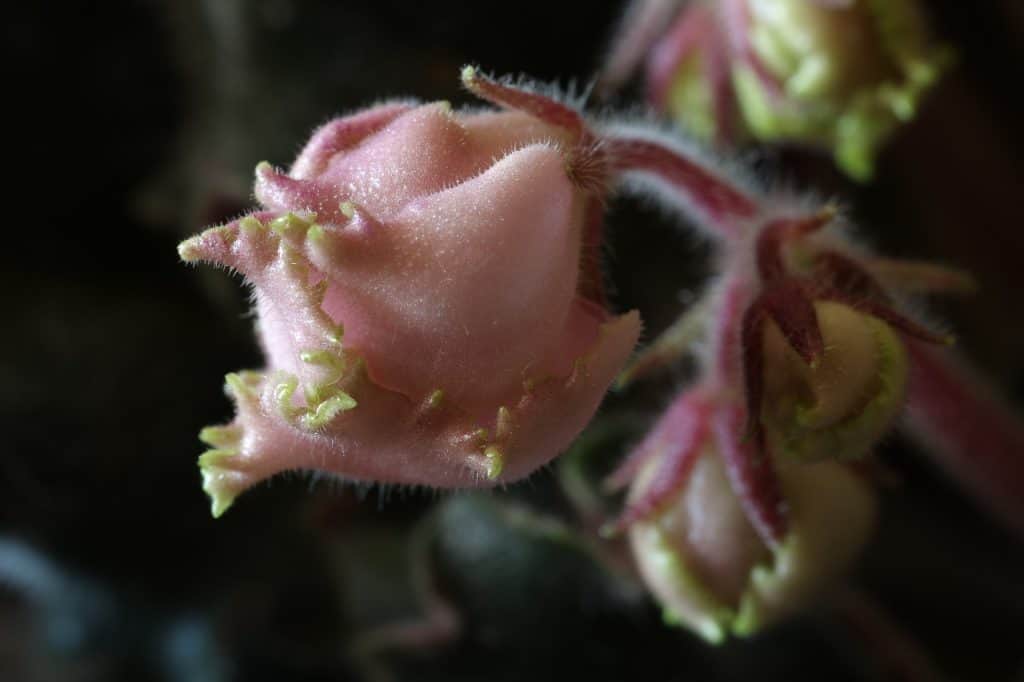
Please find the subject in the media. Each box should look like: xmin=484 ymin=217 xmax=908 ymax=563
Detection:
xmin=179 ymin=68 xmax=770 ymax=515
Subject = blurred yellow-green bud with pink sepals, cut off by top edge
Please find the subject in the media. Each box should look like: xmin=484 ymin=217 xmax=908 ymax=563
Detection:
xmin=605 ymin=0 xmax=951 ymax=180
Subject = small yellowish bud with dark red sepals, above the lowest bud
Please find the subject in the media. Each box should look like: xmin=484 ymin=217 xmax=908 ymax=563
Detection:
xmin=741 ymin=209 xmax=951 ymax=461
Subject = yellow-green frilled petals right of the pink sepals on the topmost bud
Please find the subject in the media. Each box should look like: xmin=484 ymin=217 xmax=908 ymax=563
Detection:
xmin=723 ymin=0 xmax=948 ymax=178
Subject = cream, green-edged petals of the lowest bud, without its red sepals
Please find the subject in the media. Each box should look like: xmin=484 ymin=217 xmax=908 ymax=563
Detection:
xmin=629 ymin=445 xmax=877 ymax=643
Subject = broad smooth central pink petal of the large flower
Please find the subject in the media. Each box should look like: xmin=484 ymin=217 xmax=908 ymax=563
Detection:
xmin=325 ymin=144 xmax=602 ymax=404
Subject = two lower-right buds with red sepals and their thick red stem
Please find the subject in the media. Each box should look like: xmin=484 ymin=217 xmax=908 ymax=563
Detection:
xmin=607 ymin=169 xmax=1024 ymax=642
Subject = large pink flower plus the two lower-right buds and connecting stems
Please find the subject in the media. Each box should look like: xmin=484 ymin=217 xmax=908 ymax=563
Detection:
xmin=179 ymin=68 xmax=1024 ymax=641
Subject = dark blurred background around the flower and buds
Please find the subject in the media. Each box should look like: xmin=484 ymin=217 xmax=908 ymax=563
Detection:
xmin=0 ymin=0 xmax=1024 ymax=682
